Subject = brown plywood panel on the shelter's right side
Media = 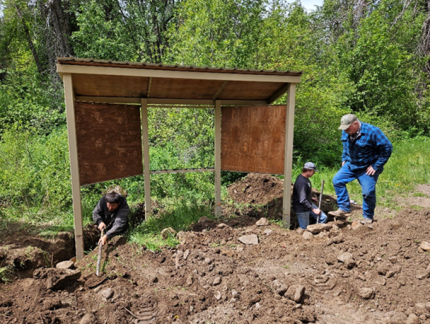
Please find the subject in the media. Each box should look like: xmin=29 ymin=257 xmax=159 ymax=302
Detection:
xmin=221 ymin=106 xmax=286 ymax=174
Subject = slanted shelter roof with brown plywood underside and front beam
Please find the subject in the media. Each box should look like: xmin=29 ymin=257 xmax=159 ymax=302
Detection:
xmin=57 ymin=58 xmax=301 ymax=105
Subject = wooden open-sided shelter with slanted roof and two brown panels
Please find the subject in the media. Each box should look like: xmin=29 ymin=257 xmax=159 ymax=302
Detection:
xmin=57 ymin=57 xmax=301 ymax=259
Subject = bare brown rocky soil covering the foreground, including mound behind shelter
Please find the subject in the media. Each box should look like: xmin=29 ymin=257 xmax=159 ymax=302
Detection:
xmin=0 ymin=174 xmax=430 ymax=324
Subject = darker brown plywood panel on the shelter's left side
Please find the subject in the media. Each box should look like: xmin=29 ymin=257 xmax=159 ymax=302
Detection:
xmin=75 ymin=102 xmax=142 ymax=186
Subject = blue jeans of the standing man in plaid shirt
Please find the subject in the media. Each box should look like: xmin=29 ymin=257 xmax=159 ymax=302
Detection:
xmin=333 ymin=163 xmax=383 ymax=219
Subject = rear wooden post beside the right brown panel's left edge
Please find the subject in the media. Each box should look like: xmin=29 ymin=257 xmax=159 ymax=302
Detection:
xmin=215 ymin=100 xmax=221 ymax=217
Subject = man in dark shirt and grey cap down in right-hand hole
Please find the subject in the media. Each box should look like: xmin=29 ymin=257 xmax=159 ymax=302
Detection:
xmin=293 ymin=162 xmax=327 ymax=229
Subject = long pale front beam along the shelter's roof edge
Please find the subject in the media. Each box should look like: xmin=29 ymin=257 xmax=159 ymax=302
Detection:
xmin=57 ymin=63 xmax=300 ymax=83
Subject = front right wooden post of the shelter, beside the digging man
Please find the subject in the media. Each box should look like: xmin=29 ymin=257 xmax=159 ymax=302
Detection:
xmin=282 ymin=83 xmax=296 ymax=228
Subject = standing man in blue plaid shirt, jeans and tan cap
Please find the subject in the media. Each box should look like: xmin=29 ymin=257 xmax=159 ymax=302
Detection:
xmin=329 ymin=114 xmax=393 ymax=224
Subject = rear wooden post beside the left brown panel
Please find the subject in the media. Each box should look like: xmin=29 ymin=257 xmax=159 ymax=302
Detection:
xmin=140 ymin=98 xmax=151 ymax=220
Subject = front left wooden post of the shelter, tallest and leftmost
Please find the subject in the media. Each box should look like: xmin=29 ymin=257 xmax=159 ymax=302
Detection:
xmin=63 ymin=74 xmax=84 ymax=260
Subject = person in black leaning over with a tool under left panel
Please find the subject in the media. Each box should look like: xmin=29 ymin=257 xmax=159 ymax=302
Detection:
xmin=93 ymin=192 xmax=130 ymax=245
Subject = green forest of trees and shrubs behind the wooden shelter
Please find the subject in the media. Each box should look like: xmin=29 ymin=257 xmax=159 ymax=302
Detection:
xmin=0 ymin=0 xmax=430 ymax=239
